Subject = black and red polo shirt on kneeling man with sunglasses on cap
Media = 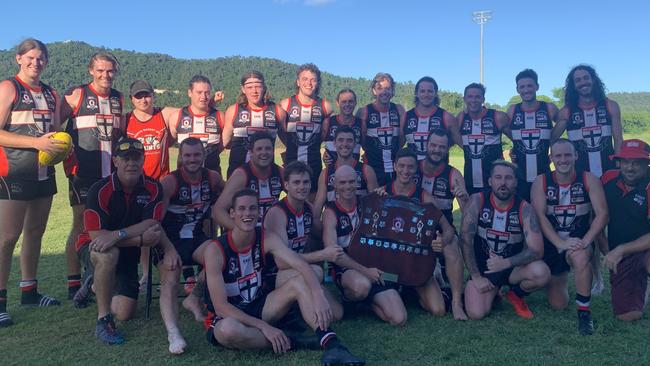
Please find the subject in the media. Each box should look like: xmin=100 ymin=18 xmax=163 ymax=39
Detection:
xmin=77 ymin=173 xmax=164 ymax=249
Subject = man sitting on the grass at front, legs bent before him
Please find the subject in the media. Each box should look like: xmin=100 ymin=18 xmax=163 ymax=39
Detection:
xmin=204 ymin=189 xmax=364 ymax=365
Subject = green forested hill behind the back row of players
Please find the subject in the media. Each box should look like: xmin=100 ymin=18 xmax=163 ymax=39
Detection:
xmin=0 ymin=42 xmax=462 ymax=112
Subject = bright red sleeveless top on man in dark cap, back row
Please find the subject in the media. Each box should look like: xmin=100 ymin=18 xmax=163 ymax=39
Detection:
xmin=126 ymin=108 xmax=171 ymax=180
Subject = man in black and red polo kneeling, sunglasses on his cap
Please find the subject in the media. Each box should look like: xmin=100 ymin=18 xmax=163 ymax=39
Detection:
xmin=79 ymin=138 xmax=167 ymax=344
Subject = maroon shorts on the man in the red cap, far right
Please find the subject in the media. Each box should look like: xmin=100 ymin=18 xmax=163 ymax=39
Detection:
xmin=609 ymin=250 xmax=650 ymax=315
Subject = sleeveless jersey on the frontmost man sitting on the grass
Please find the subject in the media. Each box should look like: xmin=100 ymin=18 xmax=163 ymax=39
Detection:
xmin=205 ymin=228 xmax=264 ymax=312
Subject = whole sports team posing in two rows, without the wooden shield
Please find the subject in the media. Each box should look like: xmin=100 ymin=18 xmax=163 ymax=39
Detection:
xmin=0 ymin=39 xmax=650 ymax=365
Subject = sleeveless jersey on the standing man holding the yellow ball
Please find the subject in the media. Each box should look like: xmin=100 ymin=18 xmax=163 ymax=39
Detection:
xmin=0 ymin=76 xmax=56 ymax=181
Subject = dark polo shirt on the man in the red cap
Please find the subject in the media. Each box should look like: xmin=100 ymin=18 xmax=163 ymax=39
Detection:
xmin=601 ymin=169 xmax=650 ymax=250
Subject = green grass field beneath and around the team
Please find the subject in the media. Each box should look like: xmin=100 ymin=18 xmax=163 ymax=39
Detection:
xmin=0 ymin=136 xmax=650 ymax=366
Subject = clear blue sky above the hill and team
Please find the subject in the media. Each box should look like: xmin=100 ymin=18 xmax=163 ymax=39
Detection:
xmin=0 ymin=0 xmax=650 ymax=104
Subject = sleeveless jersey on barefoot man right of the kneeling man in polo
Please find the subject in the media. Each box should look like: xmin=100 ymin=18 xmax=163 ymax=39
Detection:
xmin=162 ymin=168 xmax=218 ymax=241
